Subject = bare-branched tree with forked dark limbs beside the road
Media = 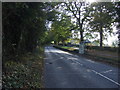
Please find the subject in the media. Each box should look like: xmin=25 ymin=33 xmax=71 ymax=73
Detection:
xmin=65 ymin=2 xmax=89 ymax=41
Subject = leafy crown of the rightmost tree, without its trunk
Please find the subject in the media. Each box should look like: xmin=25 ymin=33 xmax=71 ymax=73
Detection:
xmin=90 ymin=2 xmax=113 ymax=29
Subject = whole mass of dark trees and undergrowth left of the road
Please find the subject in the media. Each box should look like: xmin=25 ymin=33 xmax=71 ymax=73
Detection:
xmin=2 ymin=2 xmax=56 ymax=88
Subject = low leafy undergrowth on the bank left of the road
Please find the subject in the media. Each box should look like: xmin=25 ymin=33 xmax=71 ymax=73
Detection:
xmin=2 ymin=47 xmax=44 ymax=89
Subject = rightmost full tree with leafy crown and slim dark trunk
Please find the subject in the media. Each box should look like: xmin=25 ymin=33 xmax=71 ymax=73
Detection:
xmin=89 ymin=2 xmax=114 ymax=47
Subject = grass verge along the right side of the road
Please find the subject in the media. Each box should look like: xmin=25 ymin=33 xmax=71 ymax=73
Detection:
xmin=55 ymin=46 xmax=120 ymax=67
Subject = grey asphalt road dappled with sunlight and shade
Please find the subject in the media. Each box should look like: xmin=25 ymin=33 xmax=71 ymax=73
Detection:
xmin=44 ymin=46 xmax=120 ymax=88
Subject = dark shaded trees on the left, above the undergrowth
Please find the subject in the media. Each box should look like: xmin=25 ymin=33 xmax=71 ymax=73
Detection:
xmin=2 ymin=2 xmax=56 ymax=55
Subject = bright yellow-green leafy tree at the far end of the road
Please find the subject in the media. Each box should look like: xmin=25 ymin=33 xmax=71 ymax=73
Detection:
xmin=51 ymin=15 xmax=71 ymax=44
